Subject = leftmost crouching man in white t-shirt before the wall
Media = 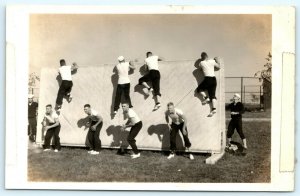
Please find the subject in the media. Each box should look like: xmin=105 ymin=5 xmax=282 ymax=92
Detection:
xmin=43 ymin=104 xmax=61 ymax=152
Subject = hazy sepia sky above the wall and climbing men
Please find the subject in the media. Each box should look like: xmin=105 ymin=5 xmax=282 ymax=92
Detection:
xmin=30 ymin=14 xmax=272 ymax=76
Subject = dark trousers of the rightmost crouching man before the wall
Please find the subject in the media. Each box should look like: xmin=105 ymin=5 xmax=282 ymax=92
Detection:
xmin=170 ymin=123 xmax=192 ymax=152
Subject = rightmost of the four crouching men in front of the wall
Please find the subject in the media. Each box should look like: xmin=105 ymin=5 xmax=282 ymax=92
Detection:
xmin=165 ymin=102 xmax=194 ymax=160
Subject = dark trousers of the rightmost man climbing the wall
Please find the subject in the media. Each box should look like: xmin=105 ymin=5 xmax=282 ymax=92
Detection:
xmin=196 ymin=77 xmax=217 ymax=100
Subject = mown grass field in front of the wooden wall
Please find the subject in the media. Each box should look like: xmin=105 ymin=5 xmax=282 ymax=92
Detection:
xmin=28 ymin=121 xmax=271 ymax=183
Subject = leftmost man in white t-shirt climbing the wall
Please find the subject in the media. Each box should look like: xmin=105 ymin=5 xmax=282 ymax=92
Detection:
xmin=56 ymin=59 xmax=78 ymax=112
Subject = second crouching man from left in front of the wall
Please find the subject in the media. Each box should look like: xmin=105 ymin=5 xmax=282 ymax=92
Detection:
xmin=84 ymin=104 xmax=103 ymax=155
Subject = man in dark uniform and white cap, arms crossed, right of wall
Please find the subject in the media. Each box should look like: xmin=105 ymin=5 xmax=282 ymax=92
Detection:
xmin=227 ymin=93 xmax=247 ymax=149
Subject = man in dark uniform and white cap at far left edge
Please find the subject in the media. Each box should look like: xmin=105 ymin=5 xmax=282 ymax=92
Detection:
xmin=28 ymin=94 xmax=38 ymax=142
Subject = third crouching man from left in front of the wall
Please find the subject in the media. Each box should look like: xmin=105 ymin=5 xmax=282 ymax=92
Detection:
xmin=122 ymin=103 xmax=143 ymax=159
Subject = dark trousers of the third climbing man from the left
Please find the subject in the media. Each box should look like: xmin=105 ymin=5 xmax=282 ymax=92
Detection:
xmin=139 ymin=70 xmax=161 ymax=96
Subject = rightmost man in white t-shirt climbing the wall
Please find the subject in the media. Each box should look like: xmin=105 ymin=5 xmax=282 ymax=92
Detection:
xmin=196 ymin=52 xmax=220 ymax=117
